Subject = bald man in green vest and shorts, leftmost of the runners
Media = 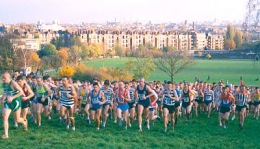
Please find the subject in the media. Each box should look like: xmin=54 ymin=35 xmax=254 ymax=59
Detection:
xmin=2 ymin=72 xmax=28 ymax=139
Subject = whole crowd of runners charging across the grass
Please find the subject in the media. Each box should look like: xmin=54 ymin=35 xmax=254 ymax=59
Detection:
xmin=1 ymin=73 xmax=260 ymax=139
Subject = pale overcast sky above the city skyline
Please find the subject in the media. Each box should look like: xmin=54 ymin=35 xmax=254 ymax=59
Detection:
xmin=0 ymin=0 xmax=248 ymax=23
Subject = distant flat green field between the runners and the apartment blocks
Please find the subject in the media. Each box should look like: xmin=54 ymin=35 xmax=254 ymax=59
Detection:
xmin=86 ymin=58 xmax=260 ymax=85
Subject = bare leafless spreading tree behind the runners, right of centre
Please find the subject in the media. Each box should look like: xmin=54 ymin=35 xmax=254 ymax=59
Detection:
xmin=154 ymin=51 xmax=194 ymax=81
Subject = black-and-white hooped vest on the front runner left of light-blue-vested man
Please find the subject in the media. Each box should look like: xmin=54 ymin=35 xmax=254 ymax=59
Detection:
xmin=60 ymin=85 xmax=74 ymax=106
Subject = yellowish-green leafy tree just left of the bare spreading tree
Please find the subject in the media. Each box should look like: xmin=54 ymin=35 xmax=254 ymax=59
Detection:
xmin=125 ymin=57 xmax=156 ymax=78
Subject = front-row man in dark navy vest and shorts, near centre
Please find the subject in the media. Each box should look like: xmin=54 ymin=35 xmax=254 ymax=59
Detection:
xmin=136 ymin=78 xmax=154 ymax=132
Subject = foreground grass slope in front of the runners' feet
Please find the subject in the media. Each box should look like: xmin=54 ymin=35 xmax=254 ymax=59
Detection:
xmin=0 ymin=110 xmax=260 ymax=148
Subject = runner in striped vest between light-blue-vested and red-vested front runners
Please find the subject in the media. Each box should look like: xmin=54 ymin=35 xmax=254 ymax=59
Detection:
xmin=101 ymin=80 xmax=114 ymax=127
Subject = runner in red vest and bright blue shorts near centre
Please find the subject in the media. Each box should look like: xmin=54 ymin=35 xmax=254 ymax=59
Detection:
xmin=116 ymin=82 xmax=130 ymax=129
